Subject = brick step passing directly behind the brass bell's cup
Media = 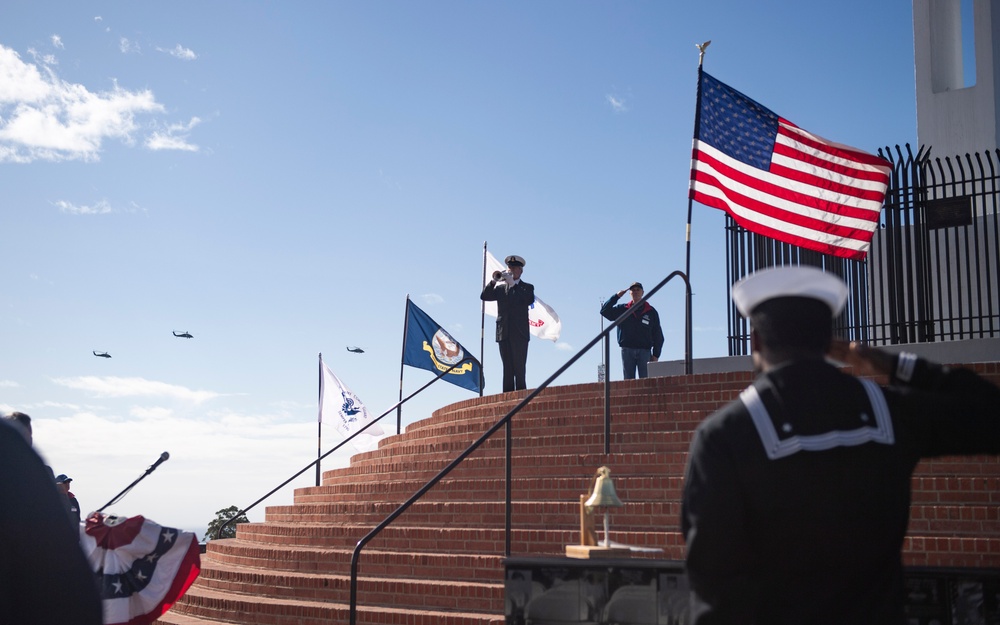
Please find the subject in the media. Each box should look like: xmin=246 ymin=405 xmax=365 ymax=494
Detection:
xmin=295 ymin=472 xmax=684 ymax=504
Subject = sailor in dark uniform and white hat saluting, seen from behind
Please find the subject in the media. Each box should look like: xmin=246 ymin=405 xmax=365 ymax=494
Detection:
xmin=681 ymin=267 xmax=1000 ymax=625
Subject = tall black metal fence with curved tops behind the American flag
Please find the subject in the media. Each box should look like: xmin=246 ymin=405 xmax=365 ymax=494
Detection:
xmin=726 ymin=145 xmax=1000 ymax=356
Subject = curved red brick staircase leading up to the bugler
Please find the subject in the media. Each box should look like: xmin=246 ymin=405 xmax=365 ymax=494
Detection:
xmin=157 ymin=363 xmax=1000 ymax=625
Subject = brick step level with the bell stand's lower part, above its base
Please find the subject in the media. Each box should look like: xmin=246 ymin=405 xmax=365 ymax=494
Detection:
xmin=234 ymin=519 xmax=680 ymax=554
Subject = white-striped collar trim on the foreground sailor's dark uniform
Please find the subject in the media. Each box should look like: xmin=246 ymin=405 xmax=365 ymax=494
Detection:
xmin=740 ymin=379 xmax=895 ymax=460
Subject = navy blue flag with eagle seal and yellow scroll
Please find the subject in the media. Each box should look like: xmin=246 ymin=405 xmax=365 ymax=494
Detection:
xmin=403 ymin=299 xmax=483 ymax=393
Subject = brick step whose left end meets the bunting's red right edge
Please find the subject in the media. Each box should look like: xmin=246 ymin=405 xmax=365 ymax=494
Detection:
xmin=195 ymin=562 xmax=504 ymax=613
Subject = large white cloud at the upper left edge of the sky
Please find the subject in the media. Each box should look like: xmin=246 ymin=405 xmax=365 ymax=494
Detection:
xmin=0 ymin=45 xmax=164 ymax=163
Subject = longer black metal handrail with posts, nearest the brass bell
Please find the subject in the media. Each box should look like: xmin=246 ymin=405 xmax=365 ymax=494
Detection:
xmin=350 ymin=271 xmax=692 ymax=625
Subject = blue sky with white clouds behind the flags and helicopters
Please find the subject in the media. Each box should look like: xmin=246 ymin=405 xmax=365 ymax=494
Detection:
xmin=0 ymin=0 xmax=916 ymax=535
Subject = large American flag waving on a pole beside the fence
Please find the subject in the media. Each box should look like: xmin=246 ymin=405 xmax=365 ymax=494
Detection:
xmin=689 ymin=71 xmax=892 ymax=260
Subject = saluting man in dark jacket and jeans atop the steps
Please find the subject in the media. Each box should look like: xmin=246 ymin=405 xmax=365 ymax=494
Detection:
xmin=601 ymin=282 xmax=663 ymax=380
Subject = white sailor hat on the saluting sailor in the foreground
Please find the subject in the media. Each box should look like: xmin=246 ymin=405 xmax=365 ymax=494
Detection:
xmin=733 ymin=266 xmax=847 ymax=317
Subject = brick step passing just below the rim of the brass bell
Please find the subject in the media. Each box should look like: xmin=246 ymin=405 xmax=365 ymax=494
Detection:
xmin=265 ymin=494 xmax=680 ymax=528
